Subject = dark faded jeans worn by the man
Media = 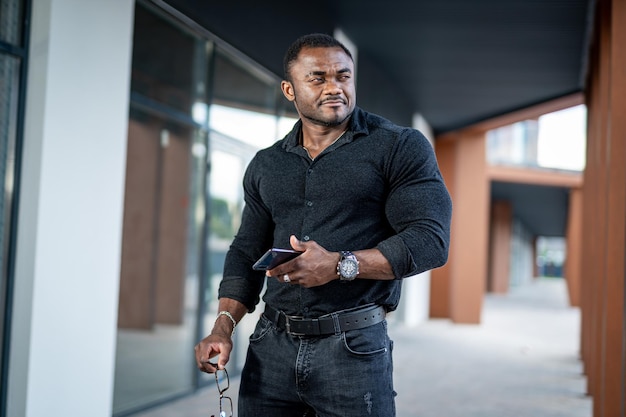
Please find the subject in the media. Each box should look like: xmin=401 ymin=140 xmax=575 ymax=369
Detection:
xmin=238 ymin=310 xmax=396 ymax=417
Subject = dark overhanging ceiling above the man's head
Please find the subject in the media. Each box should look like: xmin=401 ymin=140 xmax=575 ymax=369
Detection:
xmin=161 ymin=0 xmax=593 ymax=134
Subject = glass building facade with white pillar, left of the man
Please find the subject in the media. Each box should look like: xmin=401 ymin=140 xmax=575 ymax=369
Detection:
xmin=0 ymin=0 xmax=428 ymax=416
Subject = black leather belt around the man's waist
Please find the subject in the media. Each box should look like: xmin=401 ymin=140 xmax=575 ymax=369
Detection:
xmin=263 ymin=305 xmax=385 ymax=336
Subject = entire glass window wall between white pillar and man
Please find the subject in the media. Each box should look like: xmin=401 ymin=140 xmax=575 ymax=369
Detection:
xmin=114 ymin=2 xmax=295 ymax=414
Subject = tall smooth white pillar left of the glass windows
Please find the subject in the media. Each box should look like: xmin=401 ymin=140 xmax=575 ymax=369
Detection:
xmin=7 ymin=0 xmax=134 ymax=417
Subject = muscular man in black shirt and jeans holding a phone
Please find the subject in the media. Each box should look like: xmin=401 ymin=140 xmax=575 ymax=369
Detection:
xmin=196 ymin=34 xmax=451 ymax=417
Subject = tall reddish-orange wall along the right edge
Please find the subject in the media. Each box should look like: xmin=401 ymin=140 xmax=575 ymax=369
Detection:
xmin=580 ymin=0 xmax=626 ymax=417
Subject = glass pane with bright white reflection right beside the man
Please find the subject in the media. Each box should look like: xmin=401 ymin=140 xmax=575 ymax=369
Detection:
xmin=202 ymin=48 xmax=281 ymax=381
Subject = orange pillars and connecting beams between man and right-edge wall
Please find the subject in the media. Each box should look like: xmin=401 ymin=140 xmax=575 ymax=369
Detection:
xmin=430 ymin=101 xmax=583 ymax=323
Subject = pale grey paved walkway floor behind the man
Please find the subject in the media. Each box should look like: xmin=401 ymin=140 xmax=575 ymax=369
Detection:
xmin=137 ymin=279 xmax=592 ymax=417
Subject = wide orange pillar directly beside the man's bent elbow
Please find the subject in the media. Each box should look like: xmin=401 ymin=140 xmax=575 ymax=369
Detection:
xmin=431 ymin=131 xmax=489 ymax=324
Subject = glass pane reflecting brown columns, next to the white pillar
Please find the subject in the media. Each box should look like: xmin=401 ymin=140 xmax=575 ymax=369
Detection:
xmin=113 ymin=4 xmax=207 ymax=413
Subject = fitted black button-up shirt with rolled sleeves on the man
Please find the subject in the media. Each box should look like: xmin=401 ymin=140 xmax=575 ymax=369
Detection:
xmin=219 ymin=107 xmax=452 ymax=317
